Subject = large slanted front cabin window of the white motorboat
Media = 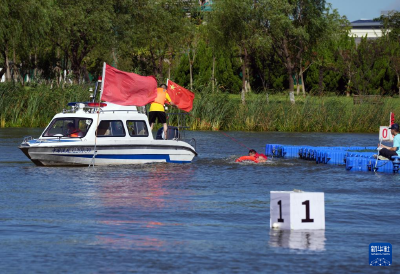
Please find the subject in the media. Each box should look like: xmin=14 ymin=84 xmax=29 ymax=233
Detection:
xmin=43 ymin=118 xmax=93 ymax=138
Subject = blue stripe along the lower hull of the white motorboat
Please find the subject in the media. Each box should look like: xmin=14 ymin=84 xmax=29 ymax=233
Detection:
xmin=51 ymin=154 xmax=191 ymax=164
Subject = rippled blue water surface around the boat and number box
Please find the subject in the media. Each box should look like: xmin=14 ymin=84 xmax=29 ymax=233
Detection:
xmin=0 ymin=129 xmax=400 ymax=273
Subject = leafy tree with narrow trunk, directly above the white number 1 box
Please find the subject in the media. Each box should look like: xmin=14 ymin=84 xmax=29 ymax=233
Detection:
xmin=258 ymin=0 xmax=326 ymax=91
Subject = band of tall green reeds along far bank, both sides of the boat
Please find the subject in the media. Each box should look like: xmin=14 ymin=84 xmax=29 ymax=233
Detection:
xmin=0 ymin=83 xmax=394 ymax=133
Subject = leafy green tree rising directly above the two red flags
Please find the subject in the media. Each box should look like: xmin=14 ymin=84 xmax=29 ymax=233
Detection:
xmin=128 ymin=0 xmax=194 ymax=81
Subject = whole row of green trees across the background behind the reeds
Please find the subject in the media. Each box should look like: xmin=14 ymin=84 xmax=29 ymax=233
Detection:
xmin=0 ymin=0 xmax=400 ymax=98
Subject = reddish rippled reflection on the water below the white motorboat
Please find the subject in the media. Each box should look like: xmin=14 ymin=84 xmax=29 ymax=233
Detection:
xmin=96 ymin=163 xmax=194 ymax=251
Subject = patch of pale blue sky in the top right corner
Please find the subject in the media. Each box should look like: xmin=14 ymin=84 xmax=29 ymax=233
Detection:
xmin=326 ymin=0 xmax=400 ymax=22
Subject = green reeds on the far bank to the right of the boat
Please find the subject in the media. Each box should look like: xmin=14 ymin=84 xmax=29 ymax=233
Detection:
xmin=188 ymin=94 xmax=400 ymax=132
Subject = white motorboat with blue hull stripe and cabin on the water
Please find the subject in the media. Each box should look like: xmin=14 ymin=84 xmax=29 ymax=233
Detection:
xmin=19 ymin=102 xmax=197 ymax=166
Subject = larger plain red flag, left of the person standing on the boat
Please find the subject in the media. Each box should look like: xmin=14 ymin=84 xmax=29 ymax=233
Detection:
xmin=101 ymin=64 xmax=157 ymax=106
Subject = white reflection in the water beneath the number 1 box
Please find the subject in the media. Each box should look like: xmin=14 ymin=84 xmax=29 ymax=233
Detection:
xmin=269 ymin=229 xmax=326 ymax=251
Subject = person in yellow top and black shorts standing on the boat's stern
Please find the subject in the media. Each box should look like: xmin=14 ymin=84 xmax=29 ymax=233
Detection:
xmin=149 ymin=84 xmax=171 ymax=139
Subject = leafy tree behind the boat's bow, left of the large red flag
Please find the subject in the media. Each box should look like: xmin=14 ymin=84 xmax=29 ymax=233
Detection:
xmin=51 ymin=0 xmax=115 ymax=83
